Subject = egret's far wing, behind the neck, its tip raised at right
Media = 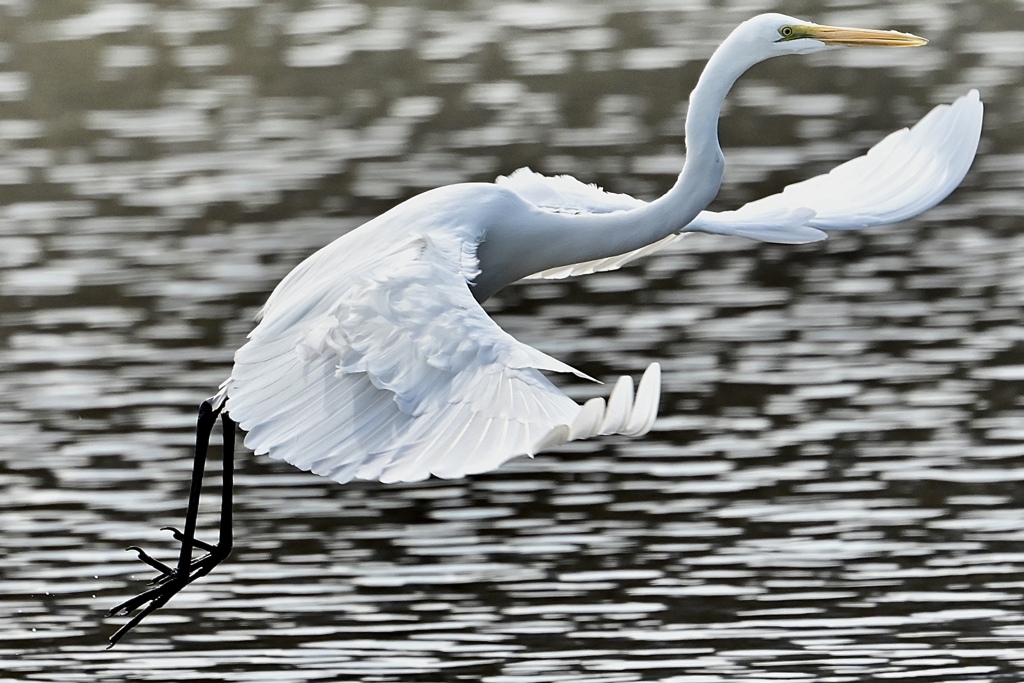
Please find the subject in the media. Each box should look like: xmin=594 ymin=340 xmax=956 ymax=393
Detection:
xmin=507 ymin=90 xmax=983 ymax=279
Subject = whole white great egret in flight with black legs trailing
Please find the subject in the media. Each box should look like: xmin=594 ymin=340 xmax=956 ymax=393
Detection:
xmin=109 ymin=14 xmax=981 ymax=645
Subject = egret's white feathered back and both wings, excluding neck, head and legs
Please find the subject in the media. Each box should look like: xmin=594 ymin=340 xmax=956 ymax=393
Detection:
xmin=218 ymin=90 xmax=982 ymax=481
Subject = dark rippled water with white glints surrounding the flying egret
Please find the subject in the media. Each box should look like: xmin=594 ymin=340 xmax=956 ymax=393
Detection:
xmin=0 ymin=0 xmax=1024 ymax=683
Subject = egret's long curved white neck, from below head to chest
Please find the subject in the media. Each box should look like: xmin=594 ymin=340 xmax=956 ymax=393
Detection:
xmin=474 ymin=36 xmax=760 ymax=301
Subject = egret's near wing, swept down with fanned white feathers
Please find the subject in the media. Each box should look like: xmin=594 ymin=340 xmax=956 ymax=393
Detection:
xmin=224 ymin=220 xmax=659 ymax=482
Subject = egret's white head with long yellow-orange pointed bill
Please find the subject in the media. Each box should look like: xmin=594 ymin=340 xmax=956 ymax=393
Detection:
xmin=734 ymin=14 xmax=928 ymax=58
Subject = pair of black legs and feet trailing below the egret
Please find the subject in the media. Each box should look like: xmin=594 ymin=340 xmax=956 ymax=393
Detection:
xmin=106 ymin=400 xmax=234 ymax=647
